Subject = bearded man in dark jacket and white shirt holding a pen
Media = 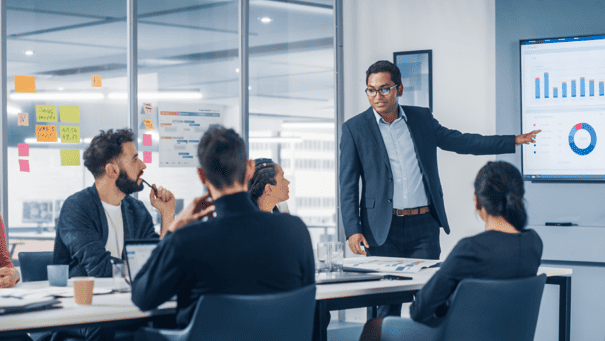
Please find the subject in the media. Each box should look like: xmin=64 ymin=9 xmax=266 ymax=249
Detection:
xmin=53 ymin=129 xmax=175 ymax=340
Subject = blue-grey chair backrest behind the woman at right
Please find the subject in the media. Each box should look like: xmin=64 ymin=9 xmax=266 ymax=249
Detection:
xmin=438 ymin=274 xmax=546 ymax=341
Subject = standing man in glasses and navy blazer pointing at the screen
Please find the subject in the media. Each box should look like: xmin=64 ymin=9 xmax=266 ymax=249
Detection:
xmin=340 ymin=60 xmax=540 ymax=317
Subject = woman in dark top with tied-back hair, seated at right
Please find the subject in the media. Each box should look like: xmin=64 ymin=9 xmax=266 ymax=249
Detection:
xmin=360 ymin=161 xmax=542 ymax=340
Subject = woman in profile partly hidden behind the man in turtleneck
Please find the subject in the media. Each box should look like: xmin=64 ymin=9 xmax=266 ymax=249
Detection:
xmin=248 ymin=158 xmax=290 ymax=213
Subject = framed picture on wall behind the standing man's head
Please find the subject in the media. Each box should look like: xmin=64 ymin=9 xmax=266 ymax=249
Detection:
xmin=393 ymin=50 xmax=433 ymax=112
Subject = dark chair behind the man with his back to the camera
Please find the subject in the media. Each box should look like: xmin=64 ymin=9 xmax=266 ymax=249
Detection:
xmin=135 ymin=285 xmax=315 ymax=341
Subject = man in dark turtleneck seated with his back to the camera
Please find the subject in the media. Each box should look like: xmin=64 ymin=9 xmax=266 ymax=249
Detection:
xmin=132 ymin=126 xmax=315 ymax=328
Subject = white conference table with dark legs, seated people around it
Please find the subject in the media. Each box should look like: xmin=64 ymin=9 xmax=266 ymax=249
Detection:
xmin=0 ymin=267 xmax=572 ymax=341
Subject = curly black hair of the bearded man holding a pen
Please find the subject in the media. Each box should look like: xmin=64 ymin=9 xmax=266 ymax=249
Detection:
xmin=83 ymin=129 xmax=134 ymax=179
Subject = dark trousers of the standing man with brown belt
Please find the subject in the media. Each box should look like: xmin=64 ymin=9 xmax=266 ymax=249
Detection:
xmin=366 ymin=212 xmax=441 ymax=318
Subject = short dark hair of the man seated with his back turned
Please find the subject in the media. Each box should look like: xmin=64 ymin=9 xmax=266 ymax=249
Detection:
xmin=197 ymin=124 xmax=248 ymax=189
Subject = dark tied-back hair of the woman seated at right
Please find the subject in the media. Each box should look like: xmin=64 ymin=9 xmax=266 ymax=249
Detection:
xmin=475 ymin=161 xmax=527 ymax=231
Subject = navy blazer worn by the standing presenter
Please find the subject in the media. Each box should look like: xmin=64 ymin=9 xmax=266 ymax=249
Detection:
xmin=340 ymin=106 xmax=515 ymax=246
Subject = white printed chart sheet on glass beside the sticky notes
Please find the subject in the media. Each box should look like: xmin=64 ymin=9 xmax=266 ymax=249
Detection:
xmin=158 ymin=105 xmax=222 ymax=167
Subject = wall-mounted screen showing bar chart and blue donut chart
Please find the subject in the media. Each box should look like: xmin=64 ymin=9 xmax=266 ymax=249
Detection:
xmin=520 ymin=35 xmax=605 ymax=181
